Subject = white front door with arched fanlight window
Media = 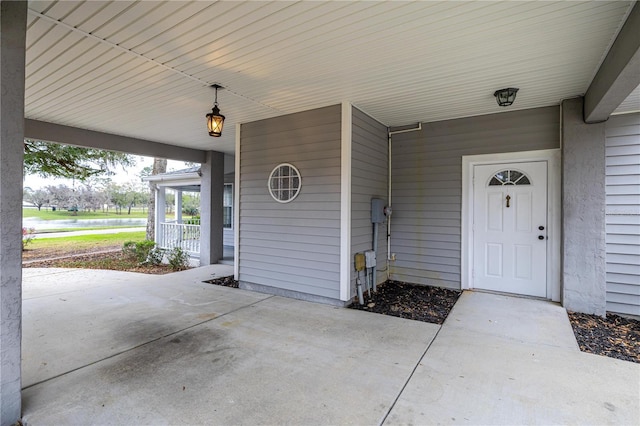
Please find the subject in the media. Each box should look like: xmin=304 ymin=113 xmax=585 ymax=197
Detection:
xmin=472 ymin=161 xmax=547 ymax=297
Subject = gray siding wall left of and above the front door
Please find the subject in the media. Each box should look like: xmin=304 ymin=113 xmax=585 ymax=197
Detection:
xmin=390 ymin=106 xmax=560 ymax=289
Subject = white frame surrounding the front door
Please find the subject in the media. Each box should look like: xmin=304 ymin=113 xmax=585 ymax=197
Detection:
xmin=460 ymin=149 xmax=562 ymax=302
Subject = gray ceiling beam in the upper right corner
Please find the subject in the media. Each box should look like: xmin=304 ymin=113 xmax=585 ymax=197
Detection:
xmin=584 ymin=3 xmax=640 ymax=123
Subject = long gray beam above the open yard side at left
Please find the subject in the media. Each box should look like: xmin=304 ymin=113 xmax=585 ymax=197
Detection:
xmin=24 ymin=118 xmax=205 ymax=163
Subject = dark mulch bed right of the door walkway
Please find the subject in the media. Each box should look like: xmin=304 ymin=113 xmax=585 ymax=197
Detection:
xmin=569 ymin=312 xmax=640 ymax=363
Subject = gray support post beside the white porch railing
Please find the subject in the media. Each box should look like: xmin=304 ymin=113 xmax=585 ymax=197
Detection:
xmin=200 ymin=151 xmax=224 ymax=266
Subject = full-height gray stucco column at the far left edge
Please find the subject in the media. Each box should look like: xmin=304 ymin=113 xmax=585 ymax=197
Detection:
xmin=0 ymin=1 xmax=27 ymax=426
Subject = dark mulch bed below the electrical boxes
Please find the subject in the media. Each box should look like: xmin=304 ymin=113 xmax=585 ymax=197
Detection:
xmin=349 ymin=280 xmax=460 ymax=324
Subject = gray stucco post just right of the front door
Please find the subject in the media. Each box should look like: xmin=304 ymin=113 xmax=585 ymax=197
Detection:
xmin=562 ymin=98 xmax=606 ymax=315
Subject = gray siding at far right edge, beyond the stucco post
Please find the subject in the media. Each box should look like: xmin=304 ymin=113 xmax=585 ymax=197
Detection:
xmin=606 ymin=114 xmax=640 ymax=315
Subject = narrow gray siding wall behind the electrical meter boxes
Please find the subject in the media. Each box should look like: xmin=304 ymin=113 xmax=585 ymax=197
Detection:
xmin=351 ymin=108 xmax=389 ymax=297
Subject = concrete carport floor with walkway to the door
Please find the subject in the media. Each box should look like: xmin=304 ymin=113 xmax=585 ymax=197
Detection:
xmin=23 ymin=265 xmax=640 ymax=425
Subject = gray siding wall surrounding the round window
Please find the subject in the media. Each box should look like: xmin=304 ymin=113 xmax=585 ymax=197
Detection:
xmin=236 ymin=105 xmax=342 ymax=299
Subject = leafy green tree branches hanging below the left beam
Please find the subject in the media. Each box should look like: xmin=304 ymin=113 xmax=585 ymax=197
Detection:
xmin=24 ymin=139 xmax=135 ymax=181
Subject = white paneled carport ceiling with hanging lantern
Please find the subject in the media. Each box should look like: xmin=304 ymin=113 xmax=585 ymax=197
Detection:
xmin=25 ymin=1 xmax=639 ymax=153
